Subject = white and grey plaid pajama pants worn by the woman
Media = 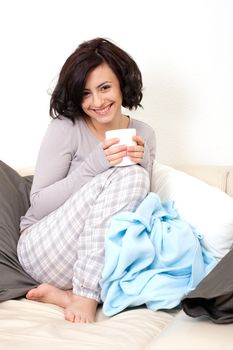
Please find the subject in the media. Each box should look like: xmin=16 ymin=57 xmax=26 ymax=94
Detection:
xmin=18 ymin=165 xmax=149 ymax=301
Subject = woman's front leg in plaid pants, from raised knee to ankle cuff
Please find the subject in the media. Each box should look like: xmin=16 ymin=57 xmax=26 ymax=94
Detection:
xmin=73 ymin=165 xmax=149 ymax=300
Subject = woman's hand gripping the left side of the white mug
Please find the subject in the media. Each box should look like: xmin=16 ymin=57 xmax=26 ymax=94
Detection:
xmin=103 ymin=138 xmax=127 ymax=166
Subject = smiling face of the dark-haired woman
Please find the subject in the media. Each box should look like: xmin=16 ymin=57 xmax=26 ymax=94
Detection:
xmin=81 ymin=63 xmax=122 ymax=126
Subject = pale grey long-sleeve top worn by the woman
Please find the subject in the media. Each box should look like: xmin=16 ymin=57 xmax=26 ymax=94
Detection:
xmin=20 ymin=118 xmax=155 ymax=231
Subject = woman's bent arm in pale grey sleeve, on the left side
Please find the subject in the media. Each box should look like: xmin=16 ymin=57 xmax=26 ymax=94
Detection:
xmin=29 ymin=120 xmax=109 ymax=220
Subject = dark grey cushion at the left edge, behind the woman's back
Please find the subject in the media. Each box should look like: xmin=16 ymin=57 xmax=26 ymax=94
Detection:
xmin=0 ymin=161 xmax=38 ymax=301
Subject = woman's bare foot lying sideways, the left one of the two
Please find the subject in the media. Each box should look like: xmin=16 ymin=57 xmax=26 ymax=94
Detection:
xmin=26 ymin=283 xmax=73 ymax=308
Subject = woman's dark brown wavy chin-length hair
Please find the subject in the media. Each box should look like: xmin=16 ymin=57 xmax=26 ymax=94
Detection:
xmin=49 ymin=38 xmax=143 ymax=122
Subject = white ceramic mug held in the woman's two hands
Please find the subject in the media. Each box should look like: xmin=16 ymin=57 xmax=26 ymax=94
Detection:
xmin=105 ymin=128 xmax=136 ymax=166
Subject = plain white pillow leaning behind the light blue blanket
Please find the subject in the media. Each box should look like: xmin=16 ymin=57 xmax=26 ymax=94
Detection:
xmin=151 ymin=163 xmax=233 ymax=259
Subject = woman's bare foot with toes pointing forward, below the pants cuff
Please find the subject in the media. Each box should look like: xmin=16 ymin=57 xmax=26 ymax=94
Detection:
xmin=65 ymin=294 xmax=98 ymax=323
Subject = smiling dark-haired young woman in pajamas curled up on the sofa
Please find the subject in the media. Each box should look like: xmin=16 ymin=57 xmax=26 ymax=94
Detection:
xmin=18 ymin=38 xmax=155 ymax=323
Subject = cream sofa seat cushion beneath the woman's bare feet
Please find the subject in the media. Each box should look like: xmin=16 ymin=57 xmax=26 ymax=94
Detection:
xmin=0 ymin=299 xmax=177 ymax=350
